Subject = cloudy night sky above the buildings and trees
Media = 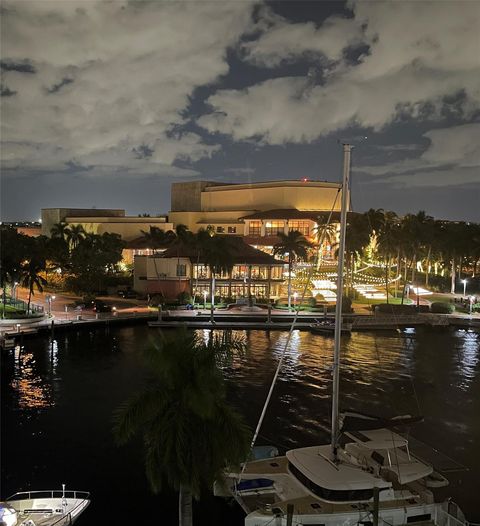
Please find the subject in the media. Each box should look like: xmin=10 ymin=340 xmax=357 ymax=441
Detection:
xmin=1 ymin=0 xmax=480 ymax=222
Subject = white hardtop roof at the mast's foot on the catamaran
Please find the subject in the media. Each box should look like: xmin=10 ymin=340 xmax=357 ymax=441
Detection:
xmin=287 ymin=445 xmax=391 ymax=491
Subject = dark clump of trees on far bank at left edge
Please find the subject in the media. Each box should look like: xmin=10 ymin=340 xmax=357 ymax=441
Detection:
xmin=0 ymin=223 xmax=124 ymax=310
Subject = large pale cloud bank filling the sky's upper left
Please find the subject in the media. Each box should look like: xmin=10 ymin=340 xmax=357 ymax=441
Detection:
xmin=2 ymin=1 xmax=255 ymax=174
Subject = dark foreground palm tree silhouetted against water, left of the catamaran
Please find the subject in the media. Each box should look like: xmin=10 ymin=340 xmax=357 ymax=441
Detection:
xmin=114 ymin=330 xmax=250 ymax=526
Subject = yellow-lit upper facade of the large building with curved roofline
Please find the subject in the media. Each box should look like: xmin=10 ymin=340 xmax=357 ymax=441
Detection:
xmin=169 ymin=181 xmax=342 ymax=243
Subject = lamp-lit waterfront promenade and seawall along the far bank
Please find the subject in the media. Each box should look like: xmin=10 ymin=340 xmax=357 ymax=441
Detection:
xmin=0 ymin=290 xmax=480 ymax=337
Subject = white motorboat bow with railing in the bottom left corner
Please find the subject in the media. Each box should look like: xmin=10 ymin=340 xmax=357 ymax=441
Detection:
xmin=0 ymin=485 xmax=90 ymax=526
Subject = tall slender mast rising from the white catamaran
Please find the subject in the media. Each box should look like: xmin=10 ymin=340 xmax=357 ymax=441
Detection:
xmin=332 ymin=144 xmax=352 ymax=458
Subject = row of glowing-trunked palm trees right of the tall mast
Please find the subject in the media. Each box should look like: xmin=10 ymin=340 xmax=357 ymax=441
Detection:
xmin=338 ymin=209 xmax=480 ymax=302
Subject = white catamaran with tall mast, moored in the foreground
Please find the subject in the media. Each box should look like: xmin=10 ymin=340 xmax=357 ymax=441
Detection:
xmin=215 ymin=144 xmax=467 ymax=526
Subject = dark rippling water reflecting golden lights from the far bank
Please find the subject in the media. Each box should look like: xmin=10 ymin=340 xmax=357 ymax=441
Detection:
xmin=1 ymin=326 xmax=480 ymax=526
